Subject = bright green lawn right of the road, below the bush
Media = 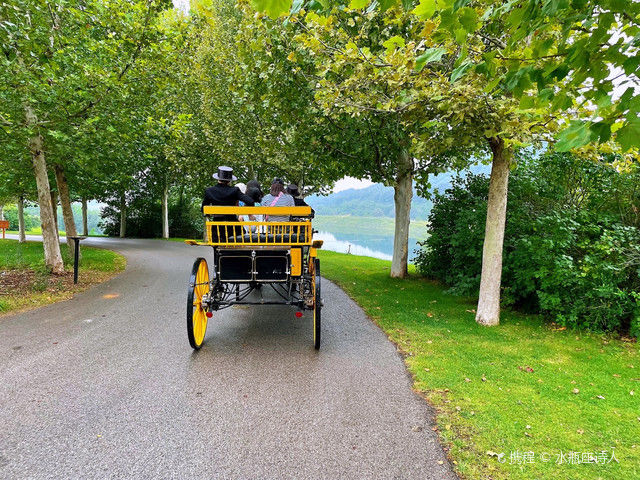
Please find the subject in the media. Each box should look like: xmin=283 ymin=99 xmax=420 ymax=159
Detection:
xmin=320 ymin=251 xmax=640 ymax=480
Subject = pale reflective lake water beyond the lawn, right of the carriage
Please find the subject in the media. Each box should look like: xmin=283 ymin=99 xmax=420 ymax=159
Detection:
xmin=313 ymin=230 xmax=418 ymax=260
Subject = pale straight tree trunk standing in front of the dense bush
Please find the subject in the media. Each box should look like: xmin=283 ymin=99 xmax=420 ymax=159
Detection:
xmin=476 ymin=137 xmax=511 ymax=325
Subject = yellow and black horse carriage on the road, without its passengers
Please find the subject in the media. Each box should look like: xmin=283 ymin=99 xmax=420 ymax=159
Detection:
xmin=185 ymin=206 xmax=322 ymax=350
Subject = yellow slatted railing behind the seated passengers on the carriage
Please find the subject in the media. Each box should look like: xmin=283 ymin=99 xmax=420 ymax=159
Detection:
xmin=197 ymin=207 xmax=313 ymax=247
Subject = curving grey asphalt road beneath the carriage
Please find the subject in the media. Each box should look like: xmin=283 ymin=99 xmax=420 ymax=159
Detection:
xmin=0 ymin=239 xmax=456 ymax=480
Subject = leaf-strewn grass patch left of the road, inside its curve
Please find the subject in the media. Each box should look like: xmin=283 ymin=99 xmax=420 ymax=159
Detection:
xmin=0 ymin=240 xmax=126 ymax=316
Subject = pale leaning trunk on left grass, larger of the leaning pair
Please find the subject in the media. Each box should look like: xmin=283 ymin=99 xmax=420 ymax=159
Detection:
xmin=25 ymin=106 xmax=64 ymax=274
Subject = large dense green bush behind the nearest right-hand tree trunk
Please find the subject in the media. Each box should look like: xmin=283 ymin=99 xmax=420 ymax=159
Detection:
xmin=416 ymin=154 xmax=640 ymax=336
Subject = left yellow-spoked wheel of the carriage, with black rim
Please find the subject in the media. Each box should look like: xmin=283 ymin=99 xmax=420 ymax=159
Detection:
xmin=187 ymin=258 xmax=210 ymax=350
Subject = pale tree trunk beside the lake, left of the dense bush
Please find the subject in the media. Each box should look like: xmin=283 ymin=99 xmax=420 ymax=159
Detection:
xmin=391 ymin=151 xmax=413 ymax=278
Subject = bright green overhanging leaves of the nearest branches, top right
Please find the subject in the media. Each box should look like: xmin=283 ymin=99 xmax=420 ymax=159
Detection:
xmin=248 ymin=0 xmax=640 ymax=155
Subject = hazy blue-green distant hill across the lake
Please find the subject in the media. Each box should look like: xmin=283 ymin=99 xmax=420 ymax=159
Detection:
xmin=306 ymin=165 xmax=491 ymax=220
